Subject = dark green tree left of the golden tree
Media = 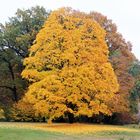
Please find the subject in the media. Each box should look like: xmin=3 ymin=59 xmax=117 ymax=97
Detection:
xmin=0 ymin=6 xmax=49 ymax=118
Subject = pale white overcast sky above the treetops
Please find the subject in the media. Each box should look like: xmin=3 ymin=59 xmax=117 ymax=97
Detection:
xmin=0 ymin=0 xmax=140 ymax=60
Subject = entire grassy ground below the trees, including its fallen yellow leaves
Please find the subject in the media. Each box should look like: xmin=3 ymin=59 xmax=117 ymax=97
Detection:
xmin=0 ymin=122 xmax=140 ymax=140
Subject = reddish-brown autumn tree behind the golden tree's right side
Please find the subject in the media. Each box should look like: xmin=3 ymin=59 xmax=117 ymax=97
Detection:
xmin=90 ymin=12 xmax=136 ymax=113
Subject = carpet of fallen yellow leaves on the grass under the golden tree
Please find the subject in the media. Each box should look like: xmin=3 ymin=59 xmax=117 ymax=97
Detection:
xmin=0 ymin=123 xmax=140 ymax=134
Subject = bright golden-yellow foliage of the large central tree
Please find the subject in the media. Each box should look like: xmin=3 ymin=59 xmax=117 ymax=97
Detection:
xmin=22 ymin=8 xmax=118 ymax=120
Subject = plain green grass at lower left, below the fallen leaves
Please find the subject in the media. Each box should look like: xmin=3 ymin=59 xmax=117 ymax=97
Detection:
xmin=0 ymin=128 xmax=66 ymax=140
